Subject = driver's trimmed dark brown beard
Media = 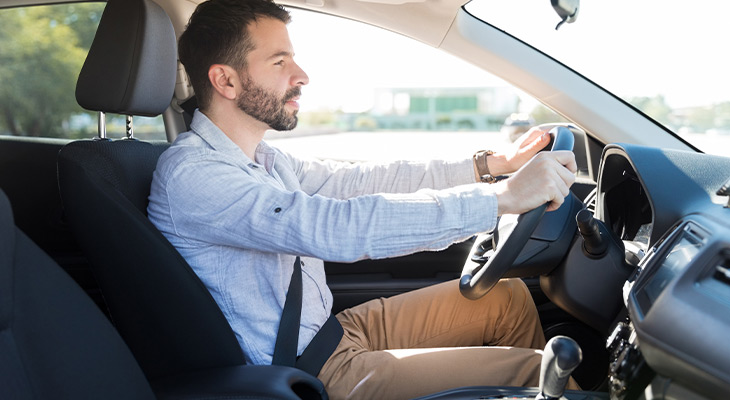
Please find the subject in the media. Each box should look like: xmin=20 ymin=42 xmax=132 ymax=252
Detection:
xmin=236 ymin=72 xmax=302 ymax=131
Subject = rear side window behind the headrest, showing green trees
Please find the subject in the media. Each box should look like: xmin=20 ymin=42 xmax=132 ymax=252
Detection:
xmin=0 ymin=3 xmax=165 ymax=140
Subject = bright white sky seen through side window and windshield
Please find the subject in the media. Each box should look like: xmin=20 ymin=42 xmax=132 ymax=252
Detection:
xmin=282 ymin=0 xmax=730 ymax=111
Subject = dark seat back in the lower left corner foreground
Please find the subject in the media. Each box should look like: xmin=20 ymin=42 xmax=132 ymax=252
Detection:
xmin=0 ymin=191 xmax=154 ymax=399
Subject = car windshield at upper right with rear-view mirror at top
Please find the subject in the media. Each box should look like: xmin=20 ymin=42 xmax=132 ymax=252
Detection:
xmin=466 ymin=0 xmax=730 ymax=156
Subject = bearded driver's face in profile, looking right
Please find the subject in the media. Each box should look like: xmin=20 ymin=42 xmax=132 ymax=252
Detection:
xmin=236 ymin=18 xmax=309 ymax=131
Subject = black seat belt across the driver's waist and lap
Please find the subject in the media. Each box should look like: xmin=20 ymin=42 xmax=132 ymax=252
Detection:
xmin=271 ymin=257 xmax=344 ymax=377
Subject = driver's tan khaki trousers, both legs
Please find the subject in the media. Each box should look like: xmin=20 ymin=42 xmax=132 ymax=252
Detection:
xmin=318 ymin=279 xmax=577 ymax=399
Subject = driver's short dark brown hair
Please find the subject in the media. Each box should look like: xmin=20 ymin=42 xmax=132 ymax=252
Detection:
xmin=178 ymin=0 xmax=291 ymax=110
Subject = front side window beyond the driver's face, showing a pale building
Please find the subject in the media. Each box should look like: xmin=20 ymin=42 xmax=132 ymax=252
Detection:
xmin=267 ymin=9 xmax=561 ymax=161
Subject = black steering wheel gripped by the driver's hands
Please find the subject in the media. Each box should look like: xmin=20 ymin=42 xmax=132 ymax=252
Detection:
xmin=459 ymin=126 xmax=574 ymax=300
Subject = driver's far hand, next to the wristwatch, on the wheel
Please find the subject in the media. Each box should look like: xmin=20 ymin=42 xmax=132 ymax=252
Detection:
xmin=487 ymin=128 xmax=550 ymax=176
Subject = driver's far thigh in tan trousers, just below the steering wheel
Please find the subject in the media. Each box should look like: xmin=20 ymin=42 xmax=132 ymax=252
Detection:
xmin=338 ymin=279 xmax=545 ymax=351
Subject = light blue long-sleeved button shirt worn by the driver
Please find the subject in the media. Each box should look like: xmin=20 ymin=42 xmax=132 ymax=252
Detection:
xmin=148 ymin=111 xmax=497 ymax=364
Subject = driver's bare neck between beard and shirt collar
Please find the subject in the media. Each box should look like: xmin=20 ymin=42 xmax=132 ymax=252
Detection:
xmin=203 ymin=105 xmax=269 ymax=161
